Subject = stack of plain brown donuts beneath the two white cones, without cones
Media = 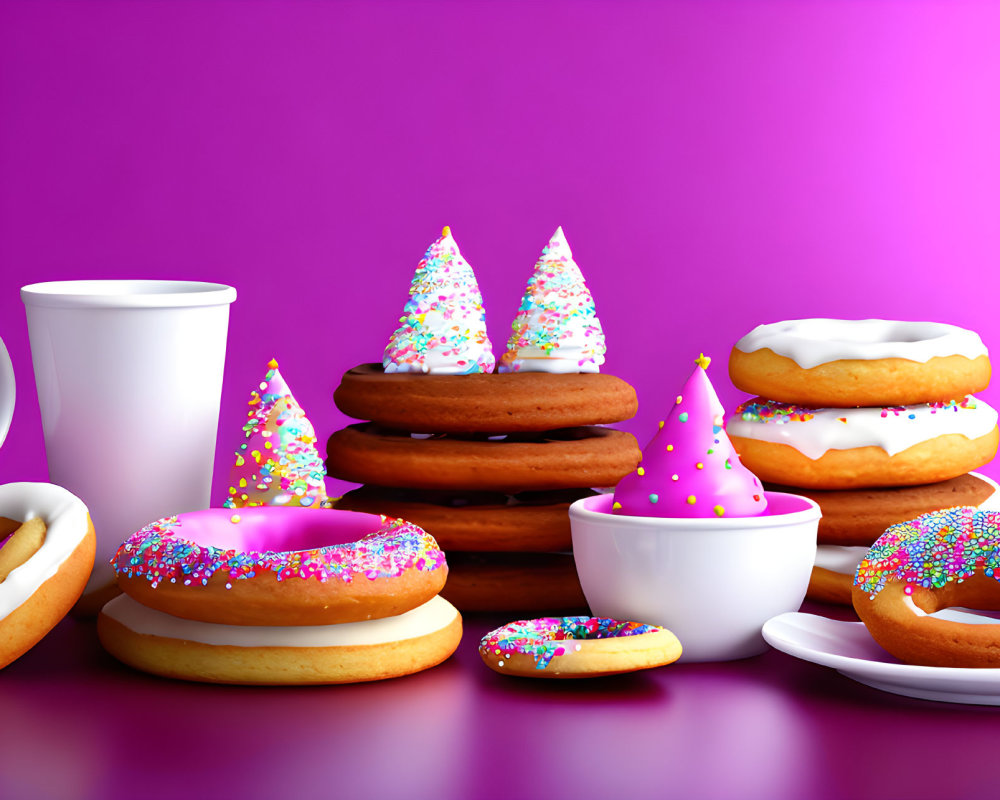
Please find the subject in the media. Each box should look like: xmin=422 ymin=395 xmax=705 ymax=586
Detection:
xmin=327 ymin=364 xmax=641 ymax=613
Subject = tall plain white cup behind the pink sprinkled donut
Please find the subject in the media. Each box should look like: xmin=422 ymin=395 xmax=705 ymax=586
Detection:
xmin=21 ymin=280 xmax=236 ymax=605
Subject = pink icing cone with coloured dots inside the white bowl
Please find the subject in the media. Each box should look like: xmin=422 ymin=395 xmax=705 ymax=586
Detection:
xmin=613 ymin=356 xmax=767 ymax=517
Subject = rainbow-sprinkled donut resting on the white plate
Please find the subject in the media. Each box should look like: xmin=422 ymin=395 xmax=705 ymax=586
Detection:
xmin=852 ymin=507 xmax=1000 ymax=668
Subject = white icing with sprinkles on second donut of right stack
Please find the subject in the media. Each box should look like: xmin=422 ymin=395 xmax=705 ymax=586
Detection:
xmin=726 ymin=397 xmax=997 ymax=460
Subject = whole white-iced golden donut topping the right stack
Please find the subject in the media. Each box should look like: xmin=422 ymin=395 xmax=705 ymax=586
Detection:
xmin=729 ymin=319 xmax=990 ymax=408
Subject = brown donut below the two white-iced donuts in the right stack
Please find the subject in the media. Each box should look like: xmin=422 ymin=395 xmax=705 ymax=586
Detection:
xmin=764 ymin=474 xmax=994 ymax=548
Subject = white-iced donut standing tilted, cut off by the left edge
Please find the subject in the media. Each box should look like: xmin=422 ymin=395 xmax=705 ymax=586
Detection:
xmin=0 ymin=483 xmax=96 ymax=668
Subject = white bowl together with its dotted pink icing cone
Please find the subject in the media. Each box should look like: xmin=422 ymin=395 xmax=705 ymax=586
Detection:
xmin=569 ymin=356 xmax=820 ymax=661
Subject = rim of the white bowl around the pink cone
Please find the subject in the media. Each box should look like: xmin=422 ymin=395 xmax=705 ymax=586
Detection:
xmin=569 ymin=492 xmax=822 ymax=531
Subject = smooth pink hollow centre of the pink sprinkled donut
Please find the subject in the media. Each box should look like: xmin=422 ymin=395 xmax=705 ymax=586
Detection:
xmin=178 ymin=507 xmax=382 ymax=553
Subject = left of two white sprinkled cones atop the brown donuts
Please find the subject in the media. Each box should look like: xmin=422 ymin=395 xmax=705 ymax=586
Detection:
xmin=382 ymin=225 xmax=496 ymax=375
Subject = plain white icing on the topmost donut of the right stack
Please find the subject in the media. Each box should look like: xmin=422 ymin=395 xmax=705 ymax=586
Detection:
xmin=736 ymin=319 xmax=987 ymax=369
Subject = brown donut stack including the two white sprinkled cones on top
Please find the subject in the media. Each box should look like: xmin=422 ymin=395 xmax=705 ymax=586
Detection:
xmin=327 ymin=228 xmax=640 ymax=613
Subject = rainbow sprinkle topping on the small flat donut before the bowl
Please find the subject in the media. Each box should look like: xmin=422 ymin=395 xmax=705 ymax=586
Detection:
xmin=479 ymin=617 xmax=662 ymax=669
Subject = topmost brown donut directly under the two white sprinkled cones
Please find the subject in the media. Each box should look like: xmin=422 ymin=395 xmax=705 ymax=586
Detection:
xmin=333 ymin=364 xmax=638 ymax=433
